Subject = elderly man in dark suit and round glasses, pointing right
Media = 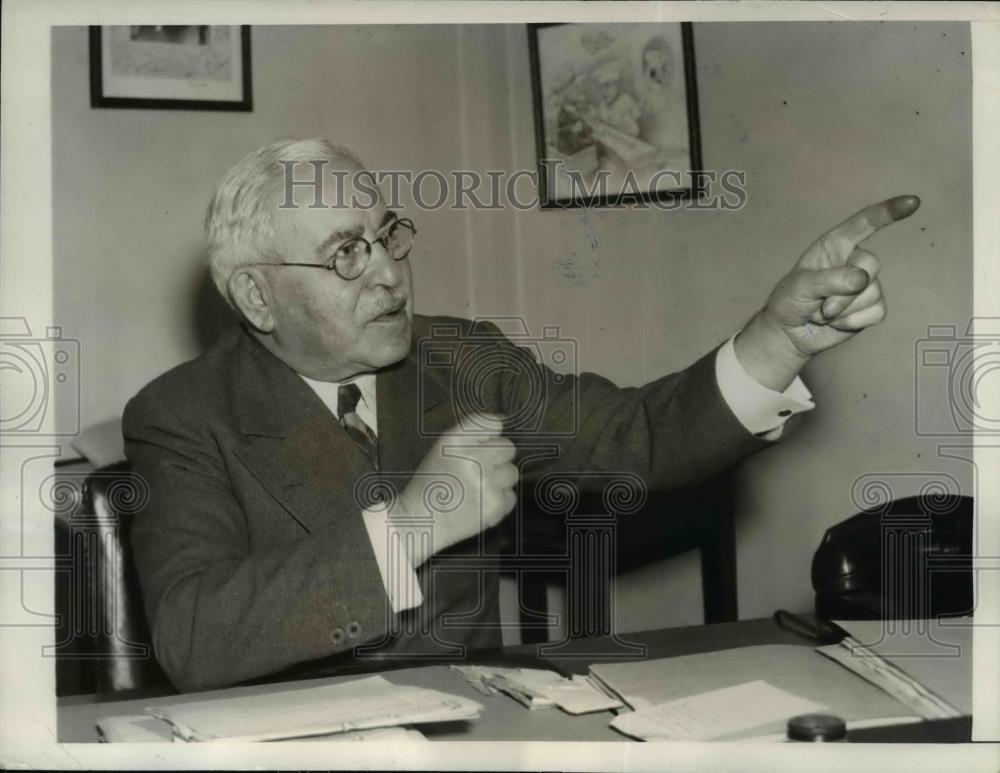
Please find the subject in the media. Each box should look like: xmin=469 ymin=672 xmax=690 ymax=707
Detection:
xmin=124 ymin=140 xmax=919 ymax=690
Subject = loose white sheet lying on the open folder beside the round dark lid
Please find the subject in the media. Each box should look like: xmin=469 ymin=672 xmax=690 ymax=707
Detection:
xmin=611 ymin=681 xmax=826 ymax=741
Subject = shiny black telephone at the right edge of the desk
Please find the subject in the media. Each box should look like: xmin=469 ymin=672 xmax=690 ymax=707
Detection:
xmin=812 ymin=495 xmax=973 ymax=620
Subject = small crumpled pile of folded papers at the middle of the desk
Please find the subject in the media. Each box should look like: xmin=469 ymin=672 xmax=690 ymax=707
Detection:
xmin=451 ymin=666 xmax=623 ymax=714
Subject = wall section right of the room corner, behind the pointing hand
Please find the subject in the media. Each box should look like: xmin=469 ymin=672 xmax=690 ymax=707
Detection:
xmin=468 ymin=23 xmax=972 ymax=630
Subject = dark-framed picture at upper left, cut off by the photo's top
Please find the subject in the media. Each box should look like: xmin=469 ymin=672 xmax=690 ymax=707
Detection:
xmin=90 ymin=24 xmax=253 ymax=111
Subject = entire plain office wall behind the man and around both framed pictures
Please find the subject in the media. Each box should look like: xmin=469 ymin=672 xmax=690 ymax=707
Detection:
xmin=53 ymin=23 xmax=972 ymax=630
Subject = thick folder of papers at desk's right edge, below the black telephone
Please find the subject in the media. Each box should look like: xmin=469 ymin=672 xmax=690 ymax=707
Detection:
xmin=817 ymin=618 xmax=972 ymax=719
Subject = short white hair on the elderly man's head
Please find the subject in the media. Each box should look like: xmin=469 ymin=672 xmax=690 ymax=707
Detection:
xmin=205 ymin=139 xmax=362 ymax=306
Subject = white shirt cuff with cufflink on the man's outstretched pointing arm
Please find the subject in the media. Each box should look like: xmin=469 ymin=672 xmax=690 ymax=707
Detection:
xmin=715 ymin=336 xmax=816 ymax=440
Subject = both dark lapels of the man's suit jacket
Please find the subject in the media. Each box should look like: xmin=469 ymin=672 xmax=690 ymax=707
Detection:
xmin=230 ymin=317 xmax=457 ymax=532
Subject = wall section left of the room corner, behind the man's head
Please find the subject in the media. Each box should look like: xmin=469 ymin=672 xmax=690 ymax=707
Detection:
xmin=52 ymin=27 xmax=477 ymax=425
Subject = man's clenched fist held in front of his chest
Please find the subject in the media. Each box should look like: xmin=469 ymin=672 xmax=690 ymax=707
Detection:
xmin=391 ymin=414 xmax=517 ymax=567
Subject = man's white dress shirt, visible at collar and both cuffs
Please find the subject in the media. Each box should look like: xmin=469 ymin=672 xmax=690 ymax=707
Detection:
xmin=302 ymin=336 xmax=815 ymax=612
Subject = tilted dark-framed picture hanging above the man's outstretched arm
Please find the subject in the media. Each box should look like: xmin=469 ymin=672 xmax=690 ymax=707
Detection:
xmin=528 ymin=22 xmax=701 ymax=208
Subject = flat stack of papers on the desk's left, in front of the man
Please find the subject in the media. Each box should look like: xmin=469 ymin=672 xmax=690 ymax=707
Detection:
xmin=132 ymin=676 xmax=482 ymax=741
